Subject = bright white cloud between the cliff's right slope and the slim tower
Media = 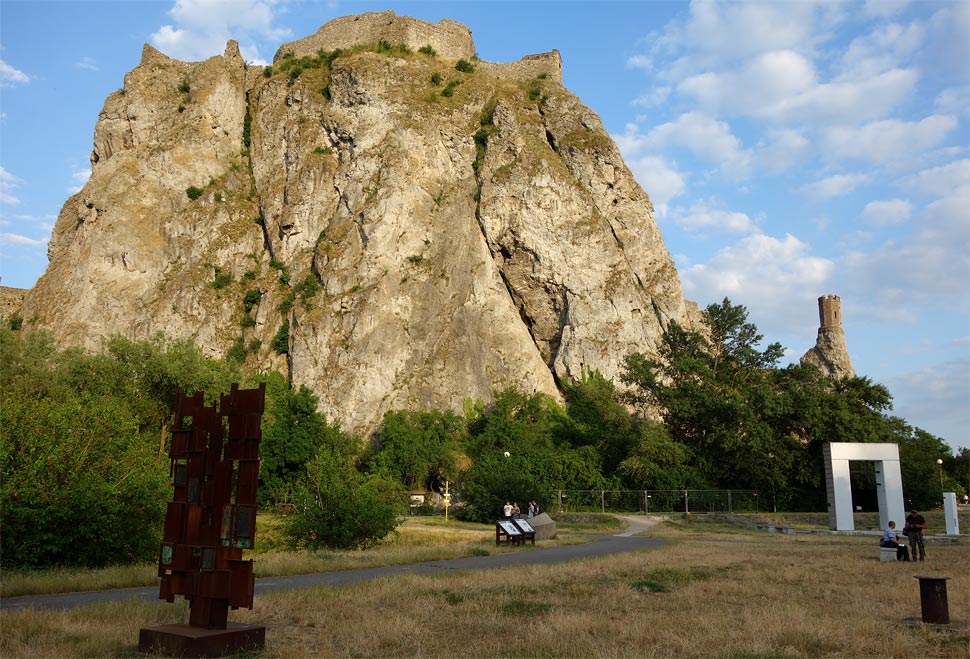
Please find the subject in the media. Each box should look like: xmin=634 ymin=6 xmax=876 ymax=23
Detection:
xmin=681 ymin=234 xmax=835 ymax=336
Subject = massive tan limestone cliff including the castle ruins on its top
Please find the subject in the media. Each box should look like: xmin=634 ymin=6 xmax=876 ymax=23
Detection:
xmin=22 ymin=12 xmax=696 ymax=431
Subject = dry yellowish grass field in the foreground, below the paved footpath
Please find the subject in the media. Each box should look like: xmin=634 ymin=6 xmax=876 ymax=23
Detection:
xmin=0 ymin=520 xmax=970 ymax=659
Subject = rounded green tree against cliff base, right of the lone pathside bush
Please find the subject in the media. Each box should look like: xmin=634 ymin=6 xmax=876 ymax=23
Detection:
xmin=371 ymin=410 xmax=467 ymax=490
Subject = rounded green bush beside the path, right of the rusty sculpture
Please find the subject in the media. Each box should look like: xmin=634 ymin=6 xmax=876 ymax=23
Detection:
xmin=285 ymin=444 xmax=404 ymax=549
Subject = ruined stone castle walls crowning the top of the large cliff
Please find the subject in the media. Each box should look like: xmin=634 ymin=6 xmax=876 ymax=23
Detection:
xmin=273 ymin=11 xmax=562 ymax=84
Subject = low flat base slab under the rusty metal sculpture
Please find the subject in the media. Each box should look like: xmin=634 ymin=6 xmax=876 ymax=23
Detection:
xmin=138 ymin=622 xmax=266 ymax=657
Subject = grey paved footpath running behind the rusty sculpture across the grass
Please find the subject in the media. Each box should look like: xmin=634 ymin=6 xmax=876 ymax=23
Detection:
xmin=0 ymin=517 xmax=666 ymax=609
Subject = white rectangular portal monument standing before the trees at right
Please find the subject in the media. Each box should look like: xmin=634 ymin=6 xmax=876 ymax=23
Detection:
xmin=822 ymin=442 xmax=906 ymax=531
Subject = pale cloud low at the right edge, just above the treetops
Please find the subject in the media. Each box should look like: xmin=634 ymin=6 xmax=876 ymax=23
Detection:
xmin=885 ymin=359 xmax=970 ymax=448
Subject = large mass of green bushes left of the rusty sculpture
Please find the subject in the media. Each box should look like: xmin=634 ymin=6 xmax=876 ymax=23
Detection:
xmin=0 ymin=328 xmax=238 ymax=567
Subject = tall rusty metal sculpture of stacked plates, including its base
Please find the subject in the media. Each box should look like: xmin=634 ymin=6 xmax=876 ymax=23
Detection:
xmin=139 ymin=384 xmax=266 ymax=657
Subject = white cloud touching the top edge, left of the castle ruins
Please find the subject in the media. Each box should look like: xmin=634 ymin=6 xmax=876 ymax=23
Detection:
xmin=151 ymin=0 xmax=290 ymax=61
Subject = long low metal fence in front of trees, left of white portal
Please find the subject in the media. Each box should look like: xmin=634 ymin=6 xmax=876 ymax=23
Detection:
xmin=540 ymin=490 xmax=759 ymax=514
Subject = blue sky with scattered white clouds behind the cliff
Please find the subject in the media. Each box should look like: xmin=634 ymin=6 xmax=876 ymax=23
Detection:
xmin=0 ymin=0 xmax=970 ymax=447
